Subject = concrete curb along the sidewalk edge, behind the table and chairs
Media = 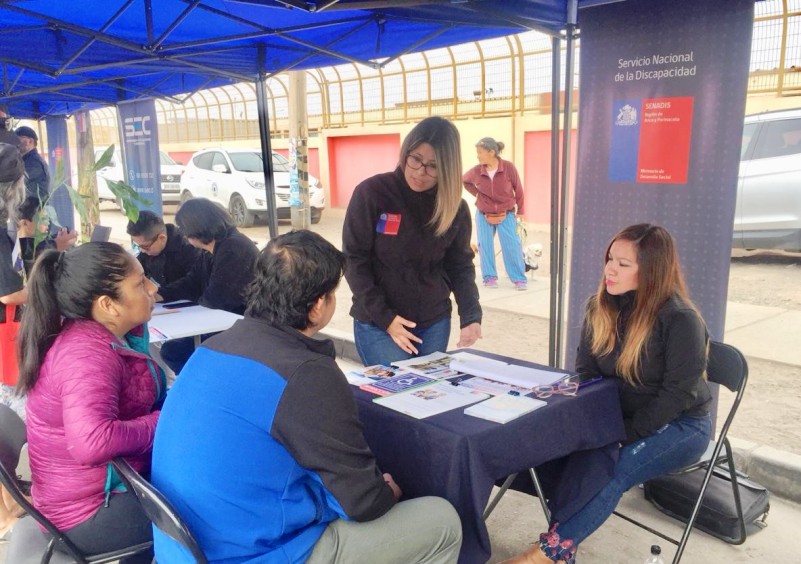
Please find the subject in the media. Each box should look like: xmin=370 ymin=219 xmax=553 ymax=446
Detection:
xmin=320 ymin=328 xmax=801 ymax=503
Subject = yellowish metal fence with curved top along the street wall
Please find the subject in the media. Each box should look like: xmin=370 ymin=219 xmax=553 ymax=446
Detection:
xmin=92 ymin=0 xmax=801 ymax=144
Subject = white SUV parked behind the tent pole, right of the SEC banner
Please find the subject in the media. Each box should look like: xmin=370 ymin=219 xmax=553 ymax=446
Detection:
xmin=181 ymin=149 xmax=325 ymax=227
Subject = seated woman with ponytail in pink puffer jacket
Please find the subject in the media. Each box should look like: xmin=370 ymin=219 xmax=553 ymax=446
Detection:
xmin=17 ymin=243 xmax=165 ymax=564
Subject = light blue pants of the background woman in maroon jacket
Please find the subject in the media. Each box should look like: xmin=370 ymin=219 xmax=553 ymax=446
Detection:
xmin=476 ymin=211 xmax=526 ymax=282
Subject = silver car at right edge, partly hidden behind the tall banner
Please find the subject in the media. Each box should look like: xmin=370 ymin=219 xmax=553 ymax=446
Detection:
xmin=732 ymin=109 xmax=801 ymax=252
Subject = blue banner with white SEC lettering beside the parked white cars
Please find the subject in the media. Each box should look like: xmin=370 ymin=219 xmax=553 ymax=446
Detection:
xmin=117 ymin=98 xmax=162 ymax=216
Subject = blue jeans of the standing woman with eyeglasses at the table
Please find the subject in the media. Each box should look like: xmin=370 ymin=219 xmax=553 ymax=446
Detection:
xmin=353 ymin=317 xmax=451 ymax=366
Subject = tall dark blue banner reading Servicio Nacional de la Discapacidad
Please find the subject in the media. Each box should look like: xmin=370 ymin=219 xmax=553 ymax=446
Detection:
xmin=565 ymin=0 xmax=754 ymax=367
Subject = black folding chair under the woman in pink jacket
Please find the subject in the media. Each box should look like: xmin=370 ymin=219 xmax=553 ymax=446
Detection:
xmin=0 ymin=404 xmax=153 ymax=564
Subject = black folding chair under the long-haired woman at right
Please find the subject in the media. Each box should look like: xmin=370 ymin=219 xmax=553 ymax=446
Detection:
xmin=615 ymin=341 xmax=748 ymax=564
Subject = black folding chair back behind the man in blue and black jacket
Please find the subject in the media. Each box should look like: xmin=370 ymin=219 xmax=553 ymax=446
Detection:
xmin=111 ymin=457 xmax=208 ymax=564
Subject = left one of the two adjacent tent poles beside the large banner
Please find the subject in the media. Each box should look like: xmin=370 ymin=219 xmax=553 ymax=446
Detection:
xmin=548 ymin=35 xmax=562 ymax=367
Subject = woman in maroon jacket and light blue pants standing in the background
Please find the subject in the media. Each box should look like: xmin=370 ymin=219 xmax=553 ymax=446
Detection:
xmin=462 ymin=137 xmax=528 ymax=290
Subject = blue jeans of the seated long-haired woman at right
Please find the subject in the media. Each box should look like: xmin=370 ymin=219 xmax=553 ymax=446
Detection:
xmin=540 ymin=415 xmax=712 ymax=562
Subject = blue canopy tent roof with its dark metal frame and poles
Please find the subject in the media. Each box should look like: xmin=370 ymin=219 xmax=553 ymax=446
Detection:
xmin=0 ymin=0 xmax=608 ymax=364
